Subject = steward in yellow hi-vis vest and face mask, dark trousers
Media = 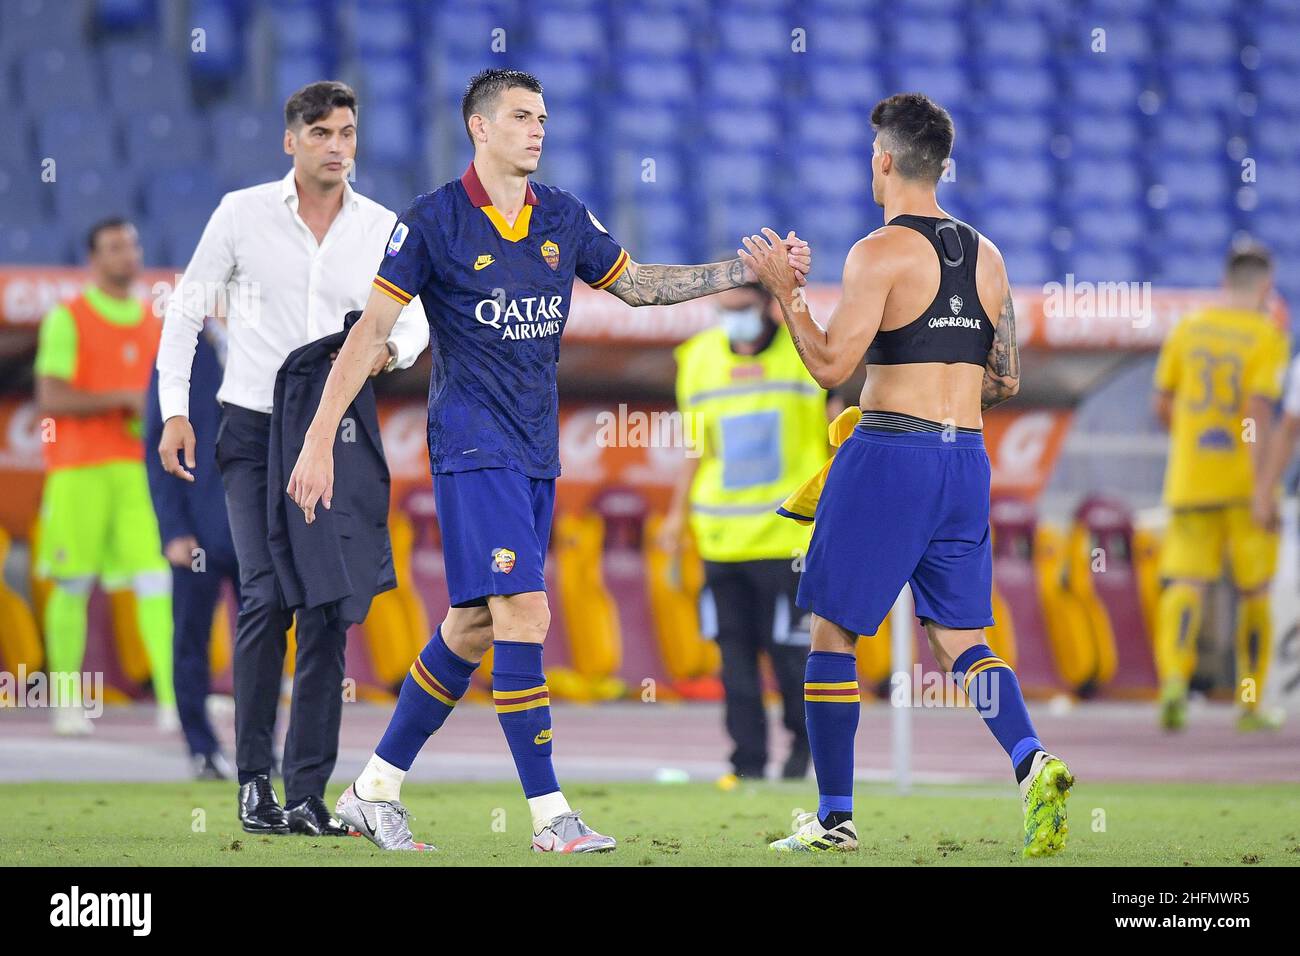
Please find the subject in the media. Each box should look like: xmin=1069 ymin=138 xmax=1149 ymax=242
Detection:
xmin=660 ymin=285 xmax=829 ymax=778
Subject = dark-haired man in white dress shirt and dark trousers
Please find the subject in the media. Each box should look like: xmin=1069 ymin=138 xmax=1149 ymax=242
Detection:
xmin=157 ymin=81 xmax=429 ymax=836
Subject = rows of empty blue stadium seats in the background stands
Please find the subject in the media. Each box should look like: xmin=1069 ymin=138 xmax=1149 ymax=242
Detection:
xmin=0 ymin=0 xmax=1300 ymax=306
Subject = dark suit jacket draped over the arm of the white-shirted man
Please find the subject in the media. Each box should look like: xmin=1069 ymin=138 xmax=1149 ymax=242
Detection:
xmin=267 ymin=312 xmax=397 ymax=623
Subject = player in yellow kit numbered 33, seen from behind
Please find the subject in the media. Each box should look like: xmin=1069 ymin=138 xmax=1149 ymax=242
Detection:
xmin=1156 ymin=246 xmax=1288 ymax=730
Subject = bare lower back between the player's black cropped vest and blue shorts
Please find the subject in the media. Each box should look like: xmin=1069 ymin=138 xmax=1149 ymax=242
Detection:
xmin=858 ymin=362 xmax=984 ymax=428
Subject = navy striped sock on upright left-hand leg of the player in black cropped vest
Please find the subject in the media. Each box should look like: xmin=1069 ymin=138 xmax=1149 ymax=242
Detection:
xmin=803 ymin=650 xmax=862 ymax=826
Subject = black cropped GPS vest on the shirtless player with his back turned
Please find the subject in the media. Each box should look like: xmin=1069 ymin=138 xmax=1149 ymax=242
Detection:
xmin=867 ymin=216 xmax=993 ymax=365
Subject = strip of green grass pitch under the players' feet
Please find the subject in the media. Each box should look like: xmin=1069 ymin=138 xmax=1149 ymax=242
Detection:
xmin=0 ymin=782 xmax=1300 ymax=866
